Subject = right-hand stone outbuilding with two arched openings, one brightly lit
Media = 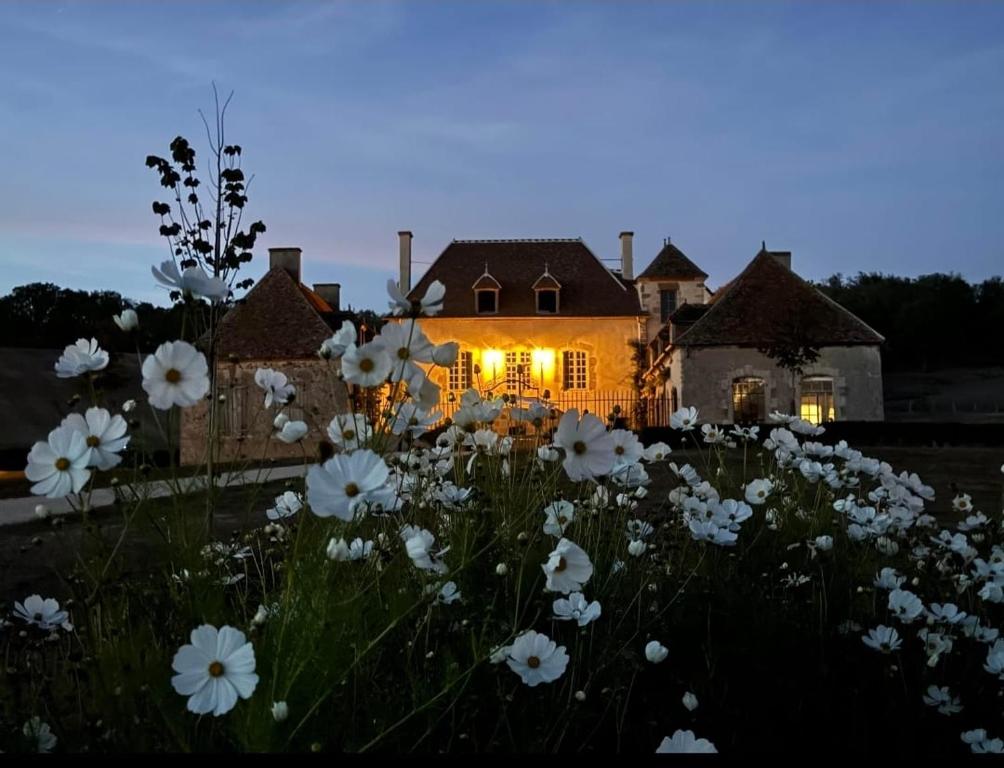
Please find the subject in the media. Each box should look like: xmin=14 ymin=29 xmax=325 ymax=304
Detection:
xmin=645 ymin=247 xmax=884 ymax=424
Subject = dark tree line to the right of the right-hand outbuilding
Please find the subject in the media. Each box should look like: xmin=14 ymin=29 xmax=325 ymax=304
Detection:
xmin=816 ymin=272 xmax=1004 ymax=370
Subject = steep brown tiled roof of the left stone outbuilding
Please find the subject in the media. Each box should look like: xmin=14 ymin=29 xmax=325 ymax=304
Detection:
xmin=219 ymin=267 xmax=343 ymax=360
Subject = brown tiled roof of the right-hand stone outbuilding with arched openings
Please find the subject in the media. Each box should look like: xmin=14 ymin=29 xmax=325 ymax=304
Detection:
xmin=673 ymin=250 xmax=884 ymax=346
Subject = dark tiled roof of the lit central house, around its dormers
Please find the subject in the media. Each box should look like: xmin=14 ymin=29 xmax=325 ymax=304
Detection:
xmin=411 ymin=239 xmax=642 ymax=317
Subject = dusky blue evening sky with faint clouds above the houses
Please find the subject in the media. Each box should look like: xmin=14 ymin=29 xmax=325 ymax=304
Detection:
xmin=0 ymin=0 xmax=1004 ymax=309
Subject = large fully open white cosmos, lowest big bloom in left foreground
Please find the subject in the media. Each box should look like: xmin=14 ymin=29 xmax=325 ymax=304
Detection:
xmin=171 ymin=624 xmax=258 ymax=717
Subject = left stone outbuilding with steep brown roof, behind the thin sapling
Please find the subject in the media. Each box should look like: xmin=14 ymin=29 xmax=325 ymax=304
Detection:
xmin=181 ymin=248 xmax=353 ymax=464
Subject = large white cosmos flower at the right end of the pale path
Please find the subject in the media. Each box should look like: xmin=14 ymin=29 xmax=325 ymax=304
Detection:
xmin=307 ymin=449 xmax=394 ymax=521
